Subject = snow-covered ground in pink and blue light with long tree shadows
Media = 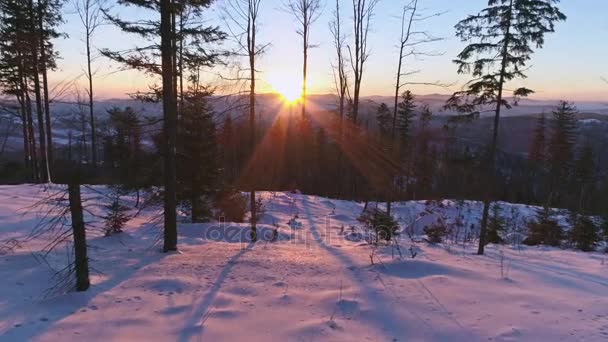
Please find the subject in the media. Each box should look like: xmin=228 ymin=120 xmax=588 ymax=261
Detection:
xmin=0 ymin=185 xmax=608 ymax=341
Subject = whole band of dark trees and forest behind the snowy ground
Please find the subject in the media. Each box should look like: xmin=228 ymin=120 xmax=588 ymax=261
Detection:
xmin=0 ymin=0 xmax=608 ymax=254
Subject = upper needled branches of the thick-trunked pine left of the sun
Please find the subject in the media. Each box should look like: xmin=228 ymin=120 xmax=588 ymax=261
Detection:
xmin=101 ymin=0 xmax=227 ymax=102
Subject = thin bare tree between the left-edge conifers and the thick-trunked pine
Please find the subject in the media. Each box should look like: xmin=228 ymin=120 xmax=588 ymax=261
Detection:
xmin=74 ymin=0 xmax=106 ymax=167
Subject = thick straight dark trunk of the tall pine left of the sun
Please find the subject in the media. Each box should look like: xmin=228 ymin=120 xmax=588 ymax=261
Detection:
xmin=160 ymin=0 xmax=177 ymax=252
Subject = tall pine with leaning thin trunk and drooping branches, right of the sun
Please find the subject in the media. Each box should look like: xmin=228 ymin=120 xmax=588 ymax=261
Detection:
xmin=446 ymin=0 xmax=566 ymax=255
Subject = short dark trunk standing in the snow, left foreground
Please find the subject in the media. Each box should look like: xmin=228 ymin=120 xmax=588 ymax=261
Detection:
xmin=68 ymin=182 xmax=90 ymax=291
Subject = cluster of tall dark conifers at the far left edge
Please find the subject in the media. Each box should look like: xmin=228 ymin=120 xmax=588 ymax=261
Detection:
xmin=0 ymin=0 xmax=63 ymax=182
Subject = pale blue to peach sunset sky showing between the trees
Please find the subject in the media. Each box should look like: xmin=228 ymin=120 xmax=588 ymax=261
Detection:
xmin=52 ymin=0 xmax=608 ymax=101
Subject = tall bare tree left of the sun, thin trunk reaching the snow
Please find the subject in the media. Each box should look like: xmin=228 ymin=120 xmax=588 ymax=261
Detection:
xmin=224 ymin=0 xmax=267 ymax=242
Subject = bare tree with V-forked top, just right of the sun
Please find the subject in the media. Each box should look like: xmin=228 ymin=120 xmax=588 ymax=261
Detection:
xmin=348 ymin=0 xmax=379 ymax=124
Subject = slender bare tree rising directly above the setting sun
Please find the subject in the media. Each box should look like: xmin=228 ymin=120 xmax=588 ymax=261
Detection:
xmin=285 ymin=0 xmax=322 ymax=118
